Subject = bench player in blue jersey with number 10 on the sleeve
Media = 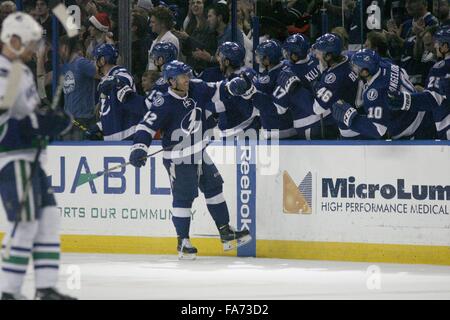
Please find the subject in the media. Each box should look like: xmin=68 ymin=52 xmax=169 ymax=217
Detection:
xmin=333 ymin=49 xmax=432 ymax=139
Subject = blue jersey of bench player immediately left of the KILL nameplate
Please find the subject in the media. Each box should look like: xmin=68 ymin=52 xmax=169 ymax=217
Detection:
xmin=252 ymin=62 xmax=297 ymax=139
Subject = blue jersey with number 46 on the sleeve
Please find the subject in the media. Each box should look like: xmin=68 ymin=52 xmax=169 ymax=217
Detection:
xmin=313 ymin=56 xmax=359 ymax=138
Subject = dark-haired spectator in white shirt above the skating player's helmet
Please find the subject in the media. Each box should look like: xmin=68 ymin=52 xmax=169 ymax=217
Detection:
xmin=147 ymin=6 xmax=180 ymax=70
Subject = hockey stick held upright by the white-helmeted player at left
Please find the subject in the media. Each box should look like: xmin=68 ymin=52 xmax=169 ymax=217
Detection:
xmin=0 ymin=1 xmax=78 ymax=259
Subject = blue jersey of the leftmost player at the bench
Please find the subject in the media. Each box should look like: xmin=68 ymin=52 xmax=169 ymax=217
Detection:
xmin=100 ymin=66 xmax=147 ymax=141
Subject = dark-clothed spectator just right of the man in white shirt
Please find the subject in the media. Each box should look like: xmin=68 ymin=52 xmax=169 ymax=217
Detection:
xmin=174 ymin=0 xmax=217 ymax=74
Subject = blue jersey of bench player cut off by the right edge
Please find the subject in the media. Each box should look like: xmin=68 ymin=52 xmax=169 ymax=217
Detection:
xmin=410 ymin=57 xmax=450 ymax=140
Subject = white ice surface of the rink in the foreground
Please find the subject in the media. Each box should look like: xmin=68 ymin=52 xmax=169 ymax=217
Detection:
xmin=15 ymin=254 xmax=450 ymax=300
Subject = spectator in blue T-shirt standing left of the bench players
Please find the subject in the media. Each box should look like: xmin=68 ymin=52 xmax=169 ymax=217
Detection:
xmin=59 ymin=36 xmax=97 ymax=140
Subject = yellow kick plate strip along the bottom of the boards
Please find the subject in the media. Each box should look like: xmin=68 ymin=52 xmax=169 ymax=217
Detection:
xmin=0 ymin=233 xmax=450 ymax=266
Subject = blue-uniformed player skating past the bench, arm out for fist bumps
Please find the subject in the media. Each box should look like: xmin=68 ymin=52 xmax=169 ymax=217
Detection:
xmin=130 ymin=60 xmax=251 ymax=259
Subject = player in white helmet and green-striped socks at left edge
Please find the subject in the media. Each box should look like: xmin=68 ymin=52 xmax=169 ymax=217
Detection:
xmin=0 ymin=12 xmax=73 ymax=300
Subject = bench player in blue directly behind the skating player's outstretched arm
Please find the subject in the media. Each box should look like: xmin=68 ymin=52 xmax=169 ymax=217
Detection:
xmin=212 ymin=42 xmax=260 ymax=137
